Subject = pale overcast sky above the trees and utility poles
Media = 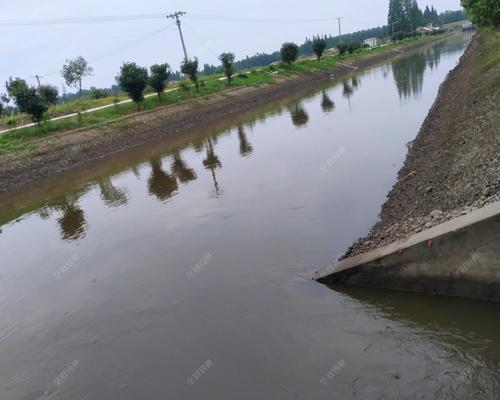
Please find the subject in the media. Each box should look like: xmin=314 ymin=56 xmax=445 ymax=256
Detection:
xmin=0 ymin=0 xmax=460 ymax=92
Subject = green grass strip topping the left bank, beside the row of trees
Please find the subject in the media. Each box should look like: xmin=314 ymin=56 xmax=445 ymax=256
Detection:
xmin=0 ymin=32 xmax=446 ymax=153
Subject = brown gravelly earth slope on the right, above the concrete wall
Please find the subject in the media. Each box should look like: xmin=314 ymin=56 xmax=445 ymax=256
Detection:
xmin=344 ymin=31 xmax=500 ymax=257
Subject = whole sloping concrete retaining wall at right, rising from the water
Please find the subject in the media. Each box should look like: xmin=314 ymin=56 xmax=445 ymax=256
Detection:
xmin=313 ymin=203 xmax=500 ymax=301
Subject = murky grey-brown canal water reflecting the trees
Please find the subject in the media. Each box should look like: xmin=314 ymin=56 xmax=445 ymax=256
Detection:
xmin=0 ymin=32 xmax=500 ymax=400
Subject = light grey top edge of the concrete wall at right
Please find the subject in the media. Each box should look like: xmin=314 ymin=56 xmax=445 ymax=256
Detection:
xmin=308 ymin=202 xmax=500 ymax=280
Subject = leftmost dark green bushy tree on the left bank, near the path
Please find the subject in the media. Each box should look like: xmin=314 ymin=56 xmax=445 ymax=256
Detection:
xmin=5 ymin=78 xmax=48 ymax=125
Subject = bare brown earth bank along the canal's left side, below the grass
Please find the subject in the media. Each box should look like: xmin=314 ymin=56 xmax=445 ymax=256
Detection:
xmin=0 ymin=36 xmax=454 ymax=193
